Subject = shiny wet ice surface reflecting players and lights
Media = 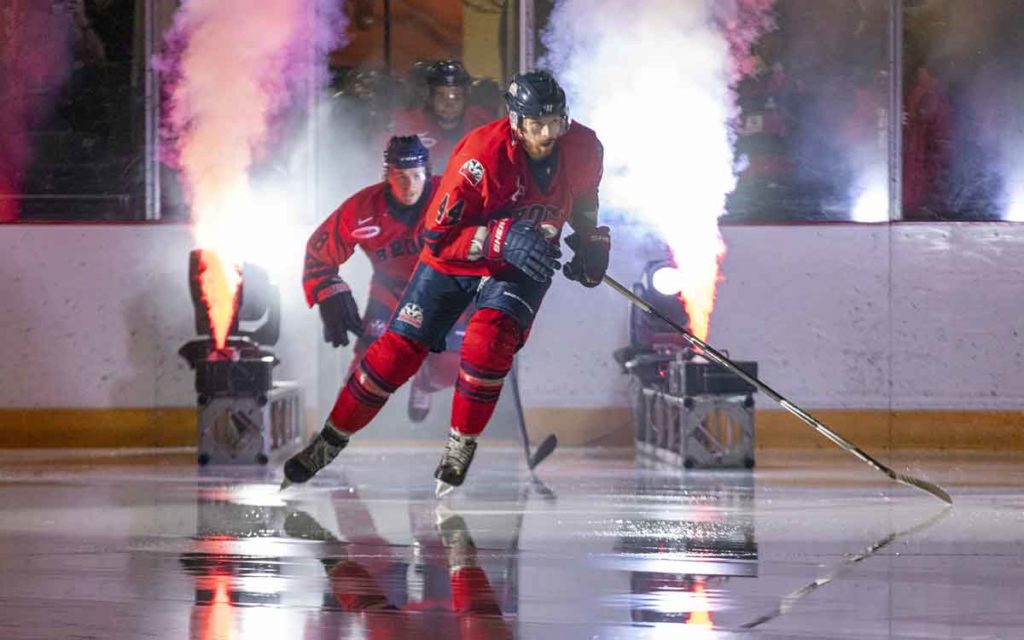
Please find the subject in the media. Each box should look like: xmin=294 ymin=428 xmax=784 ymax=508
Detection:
xmin=0 ymin=438 xmax=1024 ymax=640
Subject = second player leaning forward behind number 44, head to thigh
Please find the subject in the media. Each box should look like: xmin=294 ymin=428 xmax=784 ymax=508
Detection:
xmin=302 ymin=135 xmax=440 ymax=367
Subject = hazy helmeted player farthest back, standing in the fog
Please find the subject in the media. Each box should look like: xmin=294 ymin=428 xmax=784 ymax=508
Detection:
xmin=392 ymin=60 xmax=494 ymax=173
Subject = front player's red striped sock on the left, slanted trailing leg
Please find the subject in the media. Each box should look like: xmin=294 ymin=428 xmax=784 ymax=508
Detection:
xmin=331 ymin=331 xmax=427 ymax=434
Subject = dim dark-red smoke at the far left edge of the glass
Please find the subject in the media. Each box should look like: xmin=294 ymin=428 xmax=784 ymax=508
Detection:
xmin=0 ymin=0 xmax=72 ymax=222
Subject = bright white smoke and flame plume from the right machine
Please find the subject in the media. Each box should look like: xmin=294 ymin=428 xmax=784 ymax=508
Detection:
xmin=545 ymin=0 xmax=774 ymax=339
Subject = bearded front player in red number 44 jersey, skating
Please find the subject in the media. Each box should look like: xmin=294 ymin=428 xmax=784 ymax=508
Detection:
xmin=285 ymin=72 xmax=610 ymax=496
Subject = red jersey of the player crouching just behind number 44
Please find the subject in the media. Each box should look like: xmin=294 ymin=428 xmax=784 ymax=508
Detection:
xmin=302 ymin=177 xmax=440 ymax=306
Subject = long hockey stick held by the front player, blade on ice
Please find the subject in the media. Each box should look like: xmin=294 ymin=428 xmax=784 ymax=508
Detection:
xmin=604 ymin=275 xmax=953 ymax=505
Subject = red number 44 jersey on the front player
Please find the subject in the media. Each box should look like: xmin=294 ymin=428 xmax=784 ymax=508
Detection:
xmin=421 ymin=118 xmax=604 ymax=275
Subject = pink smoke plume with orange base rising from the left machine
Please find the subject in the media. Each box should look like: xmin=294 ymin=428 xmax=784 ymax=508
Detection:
xmin=158 ymin=0 xmax=345 ymax=344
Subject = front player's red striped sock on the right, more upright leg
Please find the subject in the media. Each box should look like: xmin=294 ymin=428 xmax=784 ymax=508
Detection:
xmin=452 ymin=309 xmax=522 ymax=436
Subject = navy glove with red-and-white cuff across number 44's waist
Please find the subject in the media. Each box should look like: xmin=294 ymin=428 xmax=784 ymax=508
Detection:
xmin=483 ymin=218 xmax=562 ymax=283
